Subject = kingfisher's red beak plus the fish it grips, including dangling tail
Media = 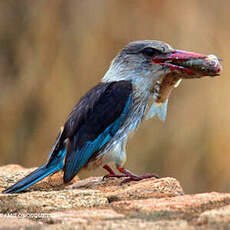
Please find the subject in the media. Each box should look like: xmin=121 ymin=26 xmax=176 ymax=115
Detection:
xmin=147 ymin=47 xmax=222 ymax=121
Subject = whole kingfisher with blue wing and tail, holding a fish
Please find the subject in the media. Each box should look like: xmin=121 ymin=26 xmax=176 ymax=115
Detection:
xmin=3 ymin=40 xmax=222 ymax=193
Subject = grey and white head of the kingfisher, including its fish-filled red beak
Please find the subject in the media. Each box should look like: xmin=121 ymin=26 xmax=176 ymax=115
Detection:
xmin=103 ymin=40 xmax=222 ymax=100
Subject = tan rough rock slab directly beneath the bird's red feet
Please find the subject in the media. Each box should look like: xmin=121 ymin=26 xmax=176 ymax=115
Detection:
xmin=67 ymin=177 xmax=184 ymax=201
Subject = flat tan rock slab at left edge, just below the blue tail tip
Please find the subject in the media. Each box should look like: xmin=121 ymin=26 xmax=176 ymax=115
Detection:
xmin=0 ymin=190 xmax=108 ymax=213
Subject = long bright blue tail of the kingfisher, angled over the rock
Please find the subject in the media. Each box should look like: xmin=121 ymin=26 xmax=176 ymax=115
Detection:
xmin=2 ymin=149 xmax=66 ymax=193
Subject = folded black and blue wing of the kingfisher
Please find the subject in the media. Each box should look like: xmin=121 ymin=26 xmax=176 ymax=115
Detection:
xmin=64 ymin=81 xmax=132 ymax=182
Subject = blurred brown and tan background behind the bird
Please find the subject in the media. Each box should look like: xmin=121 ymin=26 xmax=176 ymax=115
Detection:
xmin=0 ymin=0 xmax=230 ymax=193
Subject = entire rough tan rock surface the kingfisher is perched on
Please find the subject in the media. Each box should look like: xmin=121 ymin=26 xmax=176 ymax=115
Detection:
xmin=0 ymin=165 xmax=230 ymax=230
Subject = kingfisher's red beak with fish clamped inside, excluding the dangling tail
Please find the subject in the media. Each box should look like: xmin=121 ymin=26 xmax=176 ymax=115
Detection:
xmin=152 ymin=50 xmax=222 ymax=78
